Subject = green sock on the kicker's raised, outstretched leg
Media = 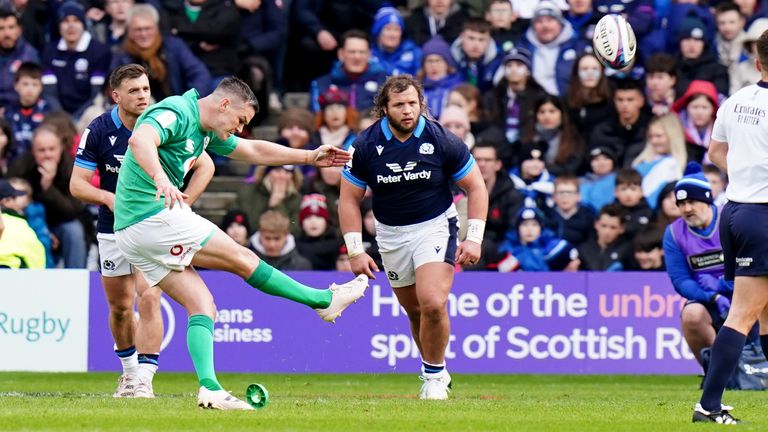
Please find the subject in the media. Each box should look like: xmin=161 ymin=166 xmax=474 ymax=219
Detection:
xmin=246 ymin=261 xmax=332 ymax=309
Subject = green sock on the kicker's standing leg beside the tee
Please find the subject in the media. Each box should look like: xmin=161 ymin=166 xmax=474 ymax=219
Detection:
xmin=187 ymin=315 xmax=222 ymax=390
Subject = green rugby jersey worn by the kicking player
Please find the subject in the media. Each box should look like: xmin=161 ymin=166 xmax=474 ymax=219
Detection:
xmin=114 ymin=89 xmax=237 ymax=231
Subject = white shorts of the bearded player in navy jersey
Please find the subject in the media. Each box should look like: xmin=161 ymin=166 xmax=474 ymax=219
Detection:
xmin=376 ymin=204 xmax=459 ymax=288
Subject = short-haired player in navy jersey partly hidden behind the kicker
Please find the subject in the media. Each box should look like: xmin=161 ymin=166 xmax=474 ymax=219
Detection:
xmin=70 ymin=64 xmax=214 ymax=398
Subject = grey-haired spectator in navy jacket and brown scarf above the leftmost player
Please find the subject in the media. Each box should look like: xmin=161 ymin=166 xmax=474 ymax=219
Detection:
xmin=112 ymin=4 xmax=211 ymax=101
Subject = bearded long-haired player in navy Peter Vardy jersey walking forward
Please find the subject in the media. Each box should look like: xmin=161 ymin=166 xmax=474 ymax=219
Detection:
xmin=339 ymin=75 xmax=488 ymax=400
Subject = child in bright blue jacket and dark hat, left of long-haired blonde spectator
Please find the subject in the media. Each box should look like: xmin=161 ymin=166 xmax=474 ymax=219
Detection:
xmin=579 ymin=147 xmax=616 ymax=210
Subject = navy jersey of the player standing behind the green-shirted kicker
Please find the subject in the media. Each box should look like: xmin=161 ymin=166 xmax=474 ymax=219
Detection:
xmin=75 ymin=107 xmax=131 ymax=234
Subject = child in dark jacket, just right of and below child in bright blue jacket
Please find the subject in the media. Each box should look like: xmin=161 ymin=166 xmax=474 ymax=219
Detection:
xmin=614 ymin=168 xmax=653 ymax=241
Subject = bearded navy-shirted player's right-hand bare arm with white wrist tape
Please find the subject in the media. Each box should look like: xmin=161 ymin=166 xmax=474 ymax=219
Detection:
xmin=456 ymin=165 xmax=488 ymax=265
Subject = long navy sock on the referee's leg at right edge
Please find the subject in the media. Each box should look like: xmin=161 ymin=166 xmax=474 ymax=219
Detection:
xmin=701 ymin=326 xmax=747 ymax=411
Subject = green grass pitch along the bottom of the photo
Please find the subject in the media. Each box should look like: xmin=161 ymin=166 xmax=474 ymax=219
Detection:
xmin=0 ymin=373 xmax=768 ymax=432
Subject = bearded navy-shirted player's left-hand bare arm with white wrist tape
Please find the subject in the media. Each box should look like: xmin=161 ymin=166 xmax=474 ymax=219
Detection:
xmin=339 ymin=178 xmax=379 ymax=279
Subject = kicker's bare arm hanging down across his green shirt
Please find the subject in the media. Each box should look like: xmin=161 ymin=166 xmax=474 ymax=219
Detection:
xmin=128 ymin=124 xmax=188 ymax=209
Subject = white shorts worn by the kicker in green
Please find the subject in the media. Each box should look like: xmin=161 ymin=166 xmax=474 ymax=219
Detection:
xmin=115 ymin=206 xmax=218 ymax=286
